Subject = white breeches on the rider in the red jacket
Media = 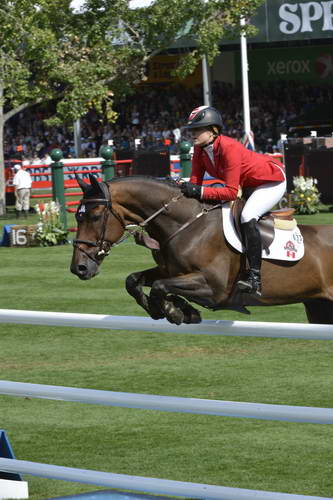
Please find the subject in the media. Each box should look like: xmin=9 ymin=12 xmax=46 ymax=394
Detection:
xmin=241 ymin=180 xmax=286 ymax=224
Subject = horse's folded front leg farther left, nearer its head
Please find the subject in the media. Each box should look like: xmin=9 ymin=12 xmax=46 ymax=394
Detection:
xmin=126 ymin=267 xmax=165 ymax=319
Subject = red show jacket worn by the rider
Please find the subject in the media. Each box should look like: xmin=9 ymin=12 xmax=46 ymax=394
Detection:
xmin=190 ymin=135 xmax=284 ymax=200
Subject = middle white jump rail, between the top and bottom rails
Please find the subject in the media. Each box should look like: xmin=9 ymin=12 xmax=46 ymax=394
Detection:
xmin=0 ymin=380 xmax=333 ymax=424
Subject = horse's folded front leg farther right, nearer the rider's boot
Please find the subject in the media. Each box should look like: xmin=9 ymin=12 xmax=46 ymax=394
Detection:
xmin=149 ymin=272 xmax=214 ymax=325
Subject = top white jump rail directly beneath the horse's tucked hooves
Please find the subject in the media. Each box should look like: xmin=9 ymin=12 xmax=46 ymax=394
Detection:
xmin=0 ymin=309 xmax=333 ymax=340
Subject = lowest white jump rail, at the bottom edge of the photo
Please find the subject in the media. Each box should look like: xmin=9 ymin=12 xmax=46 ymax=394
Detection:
xmin=0 ymin=458 xmax=332 ymax=500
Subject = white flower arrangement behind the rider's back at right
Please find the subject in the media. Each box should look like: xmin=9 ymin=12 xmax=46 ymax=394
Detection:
xmin=291 ymin=176 xmax=320 ymax=214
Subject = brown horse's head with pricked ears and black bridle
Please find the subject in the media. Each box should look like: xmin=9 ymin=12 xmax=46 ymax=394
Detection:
xmin=71 ymin=174 xmax=125 ymax=280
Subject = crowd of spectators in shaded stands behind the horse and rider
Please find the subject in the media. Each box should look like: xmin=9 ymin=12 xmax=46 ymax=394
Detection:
xmin=4 ymin=81 xmax=333 ymax=164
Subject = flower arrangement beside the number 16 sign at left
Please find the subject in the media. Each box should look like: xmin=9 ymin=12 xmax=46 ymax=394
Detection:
xmin=34 ymin=201 xmax=68 ymax=247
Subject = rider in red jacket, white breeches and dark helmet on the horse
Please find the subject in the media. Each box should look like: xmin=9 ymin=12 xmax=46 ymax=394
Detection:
xmin=181 ymin=106 xmax=286 ymax=296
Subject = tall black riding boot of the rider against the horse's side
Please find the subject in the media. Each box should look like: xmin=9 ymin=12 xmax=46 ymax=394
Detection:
xmin=237 ymin=219 xmax=262 ymax=296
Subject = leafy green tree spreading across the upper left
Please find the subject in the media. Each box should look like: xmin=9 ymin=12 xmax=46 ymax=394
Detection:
xmin=0 ymin=0 xmax=262 ymax=214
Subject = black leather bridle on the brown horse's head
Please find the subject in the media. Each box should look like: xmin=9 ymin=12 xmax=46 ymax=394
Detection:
xmin=73 ymin=182 xmax=126 ymax=265
